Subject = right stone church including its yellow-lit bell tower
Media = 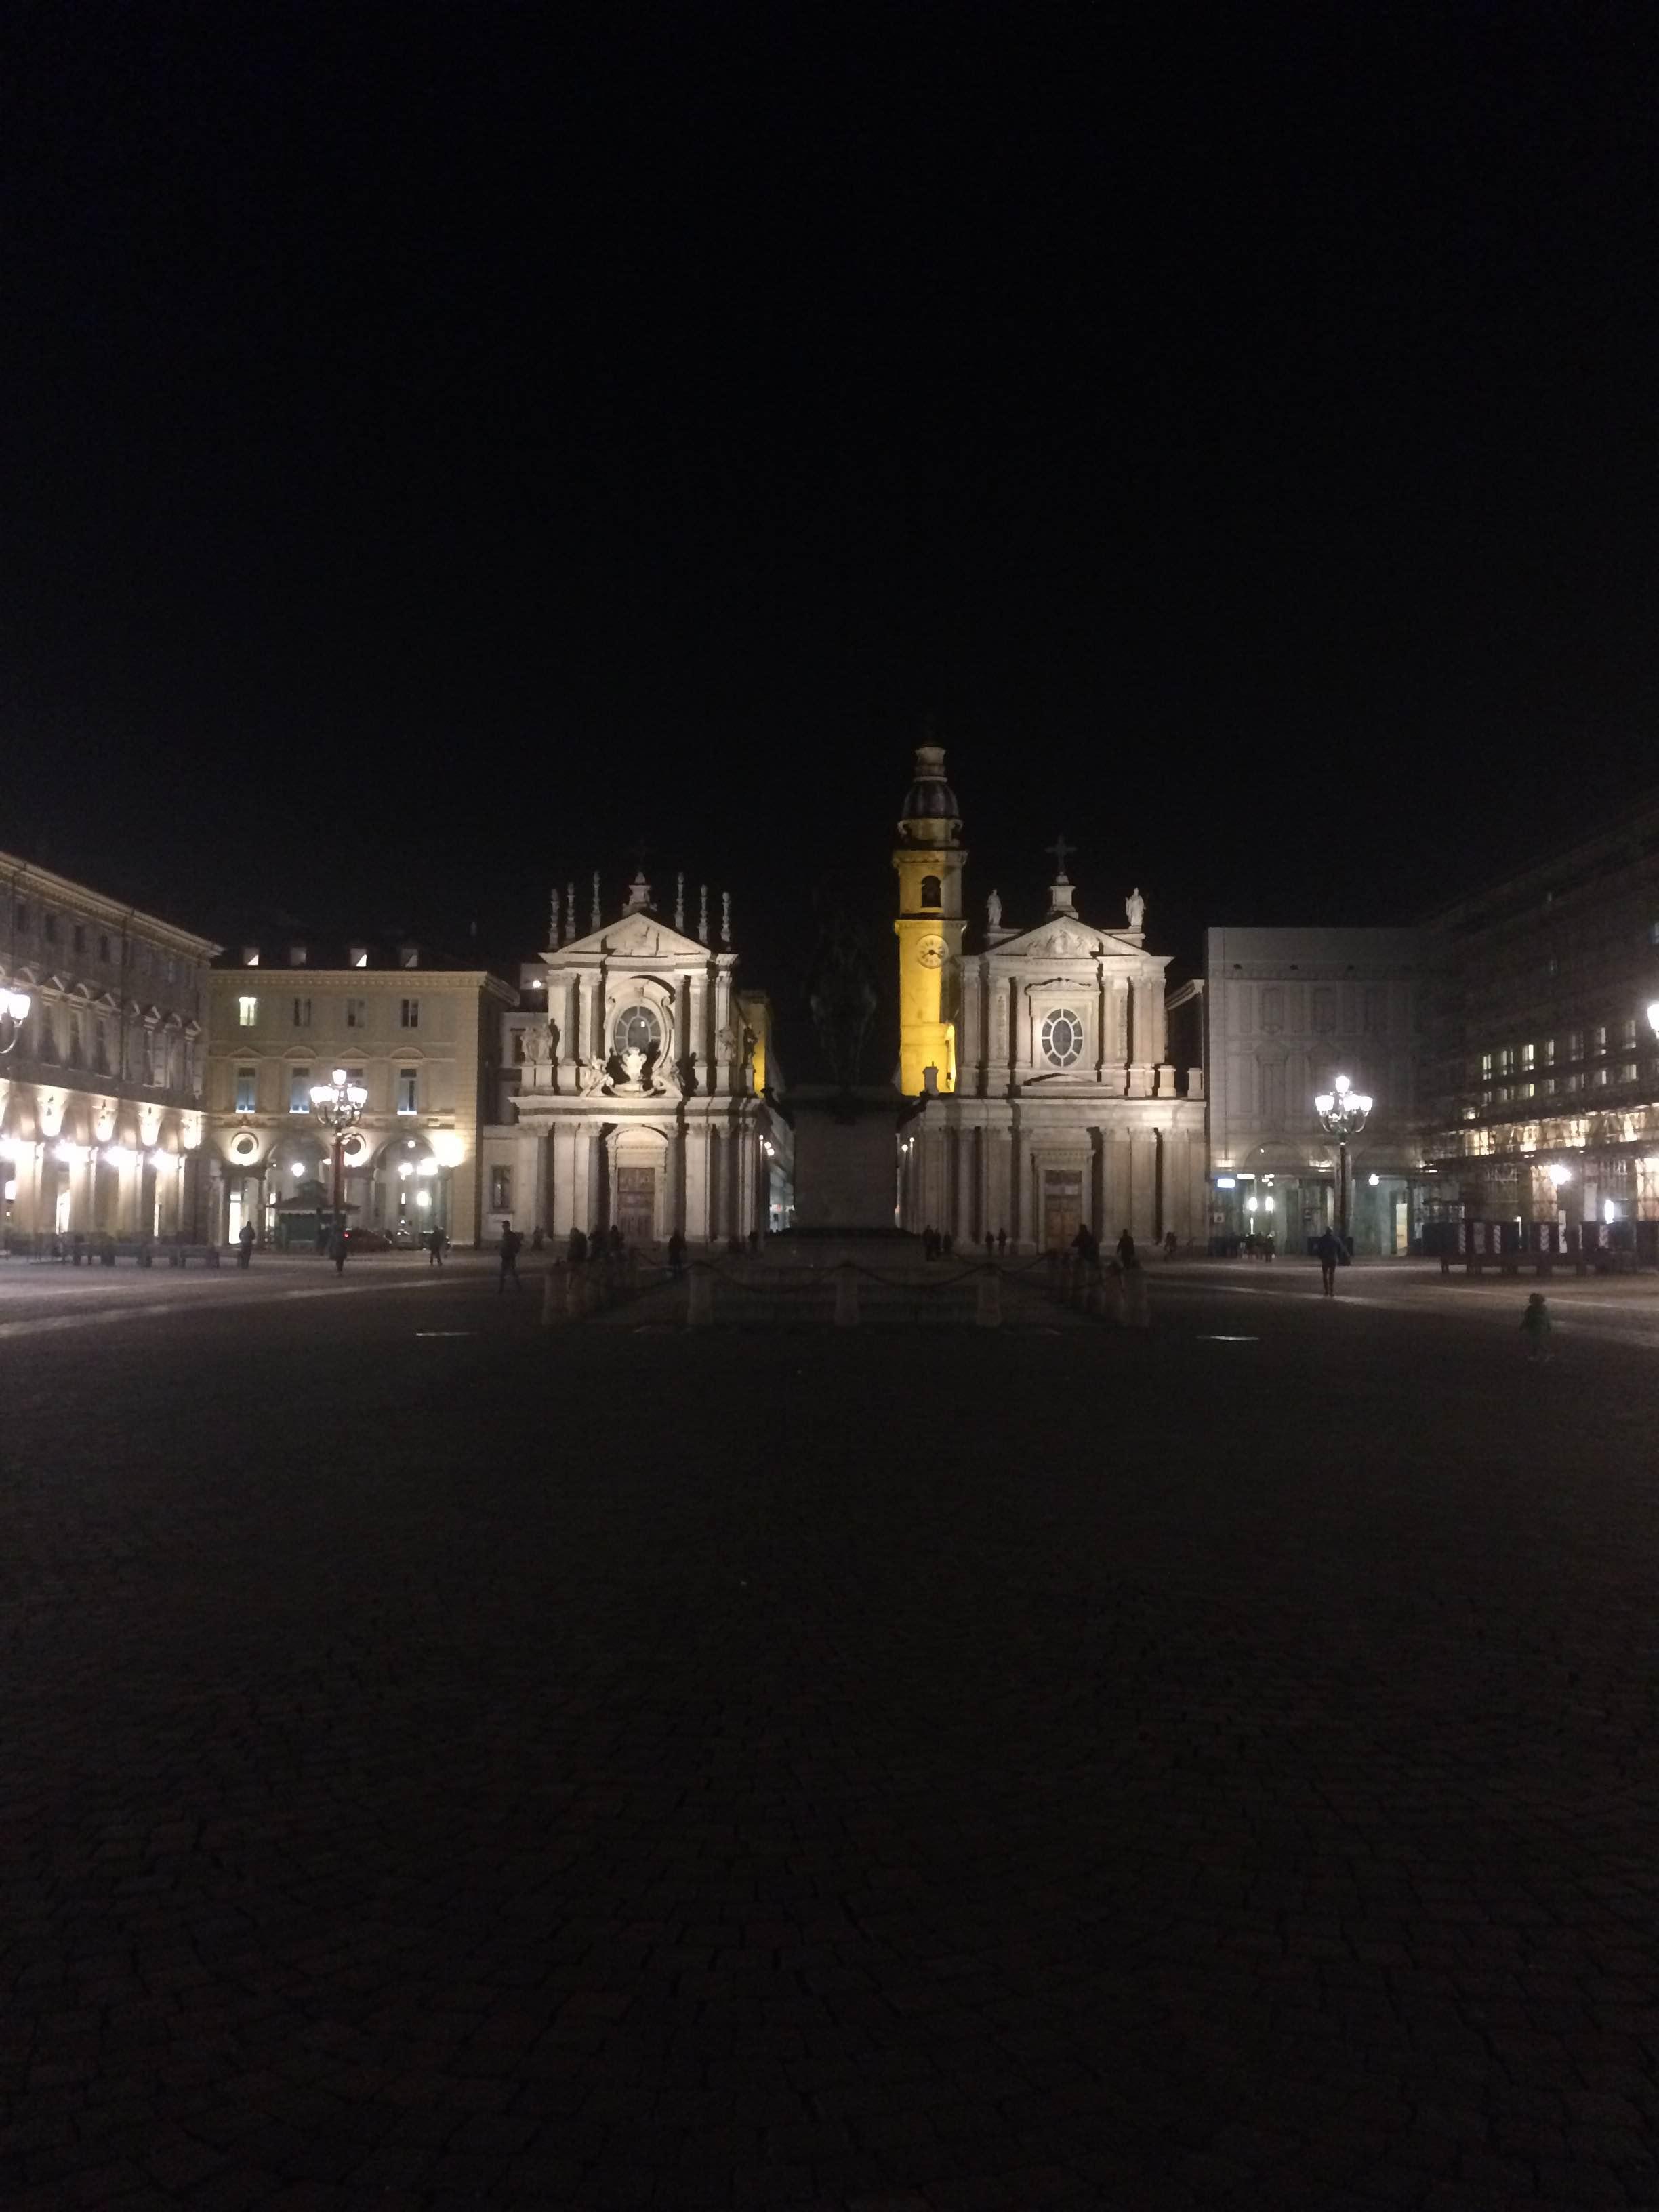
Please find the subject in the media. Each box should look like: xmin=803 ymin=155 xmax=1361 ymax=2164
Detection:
xmin=894 ymin=745 xmax=1206 ymax=1252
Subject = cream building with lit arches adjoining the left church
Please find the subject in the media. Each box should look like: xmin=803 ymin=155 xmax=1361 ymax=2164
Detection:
xmin=208 ymin=940 xmax=518 ymax=1243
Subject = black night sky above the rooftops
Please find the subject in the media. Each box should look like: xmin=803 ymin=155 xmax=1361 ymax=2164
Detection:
xmin=0 ymin=0 xmax=1659 ymax=1040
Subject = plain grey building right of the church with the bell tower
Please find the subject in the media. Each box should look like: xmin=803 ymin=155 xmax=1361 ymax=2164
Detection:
xmin=1170 ymin=929 xmax=1435 ymax=1254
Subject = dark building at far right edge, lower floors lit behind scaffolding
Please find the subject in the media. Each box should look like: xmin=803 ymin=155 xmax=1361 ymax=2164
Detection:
xmin=1425 ymin=798 xmax=1659 ymax=1256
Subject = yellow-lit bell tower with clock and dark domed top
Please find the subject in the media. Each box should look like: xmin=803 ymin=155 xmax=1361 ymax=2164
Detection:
xmin=894 ymin=745 xmax=966 ymax=1097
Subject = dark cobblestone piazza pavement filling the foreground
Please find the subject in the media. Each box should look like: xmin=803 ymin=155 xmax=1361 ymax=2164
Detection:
xmin=0 ymin=1258 xmax=1659 ymax=2212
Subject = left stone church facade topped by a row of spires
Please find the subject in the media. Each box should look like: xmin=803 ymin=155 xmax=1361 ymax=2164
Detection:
xmin=485 ymin=874 xmax=792 ymax=1246
